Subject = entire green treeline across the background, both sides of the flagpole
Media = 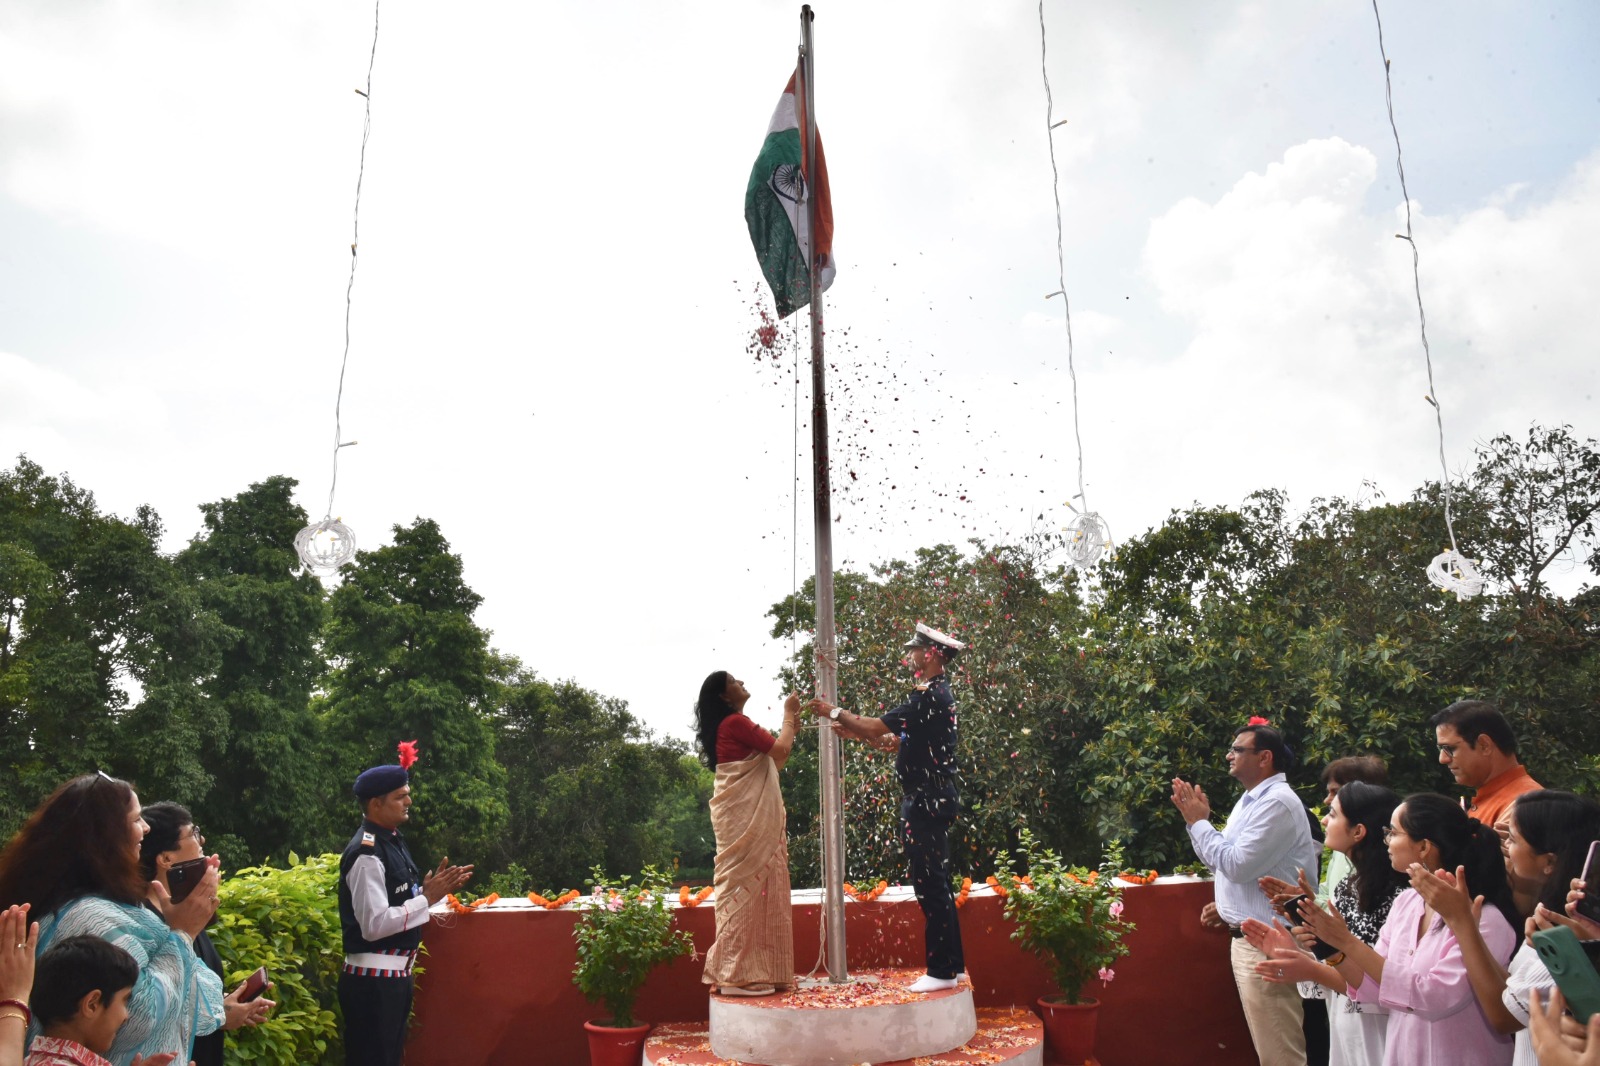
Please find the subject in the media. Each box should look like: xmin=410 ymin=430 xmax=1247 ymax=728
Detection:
xmin=0 ymin=426 xmax=1600 ymax=890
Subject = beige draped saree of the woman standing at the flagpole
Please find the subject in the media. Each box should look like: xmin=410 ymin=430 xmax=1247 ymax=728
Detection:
xmin=701 ymin=752 xmax=795 ymax=986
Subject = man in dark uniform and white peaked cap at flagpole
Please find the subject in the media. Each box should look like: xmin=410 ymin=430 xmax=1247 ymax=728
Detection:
xmin=810 ymin=623 xmax=966 ymax=992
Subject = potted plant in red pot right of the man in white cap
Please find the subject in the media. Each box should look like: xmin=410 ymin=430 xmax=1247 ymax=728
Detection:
xmin=995 ymin=829 xmax=1134 ymax=1064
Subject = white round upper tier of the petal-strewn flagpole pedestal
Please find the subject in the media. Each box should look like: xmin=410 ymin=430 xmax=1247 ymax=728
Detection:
xmin=710 ymin=970 xmax=978 ymax=1066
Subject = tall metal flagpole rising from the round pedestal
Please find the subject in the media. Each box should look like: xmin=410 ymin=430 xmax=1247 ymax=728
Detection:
xmin=795 ymin=5 xmax=850 ymax=984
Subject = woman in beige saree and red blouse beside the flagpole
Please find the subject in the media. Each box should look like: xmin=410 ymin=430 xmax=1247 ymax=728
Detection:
xmin=694 ymin=671 xmax=800 ymax=996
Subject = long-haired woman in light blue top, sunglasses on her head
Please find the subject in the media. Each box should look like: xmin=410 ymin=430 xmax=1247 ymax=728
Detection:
xmin=0 ymin=773 xmax=222 ymax=1066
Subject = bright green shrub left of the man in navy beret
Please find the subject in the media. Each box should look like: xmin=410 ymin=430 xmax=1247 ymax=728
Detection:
xmin=210 ymin=853 xmax=344 ymax=1066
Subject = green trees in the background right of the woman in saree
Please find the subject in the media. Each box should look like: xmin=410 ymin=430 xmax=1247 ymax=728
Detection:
xmin=770 ymin=427 xmax=1600 ymax=884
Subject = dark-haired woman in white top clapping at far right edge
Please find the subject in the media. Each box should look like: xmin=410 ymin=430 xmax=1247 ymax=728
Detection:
xmin=1413 ymin=789 xmax=1600 ymax=1066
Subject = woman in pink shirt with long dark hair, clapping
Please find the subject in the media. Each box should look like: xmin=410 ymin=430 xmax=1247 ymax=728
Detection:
xmin=1274 ymin=792 xmax=1518 ymax=1066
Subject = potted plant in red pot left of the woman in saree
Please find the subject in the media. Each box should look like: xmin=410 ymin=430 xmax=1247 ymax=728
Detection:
xmin=573 ymin=866 xmax=694 ymax=1066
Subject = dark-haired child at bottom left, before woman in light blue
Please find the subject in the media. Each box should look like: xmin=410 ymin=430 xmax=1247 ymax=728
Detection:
xmin=24 ymin=936 xmax=178 ymax=1066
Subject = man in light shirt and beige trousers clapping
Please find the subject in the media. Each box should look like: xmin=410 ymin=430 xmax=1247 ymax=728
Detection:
xmin=1173 ymin=719 xmax=1320 ymax=1066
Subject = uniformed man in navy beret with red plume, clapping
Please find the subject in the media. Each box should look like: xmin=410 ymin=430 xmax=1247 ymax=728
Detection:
xmin=339 ymin=747 xmax=472 ymax=1066
